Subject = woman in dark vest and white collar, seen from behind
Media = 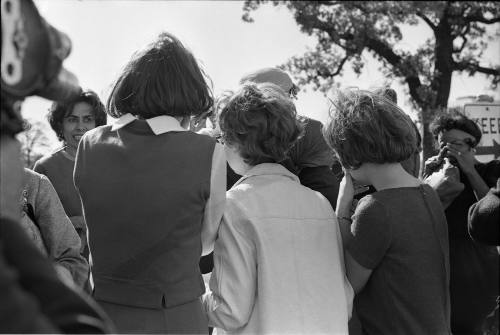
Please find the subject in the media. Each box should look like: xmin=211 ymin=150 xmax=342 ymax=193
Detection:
xmin=75 ymin=33 xmax=226 ymax=334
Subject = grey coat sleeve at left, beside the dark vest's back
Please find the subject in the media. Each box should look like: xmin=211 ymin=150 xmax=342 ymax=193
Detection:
xmin=30 ymin=176 xmax=89 ymax=287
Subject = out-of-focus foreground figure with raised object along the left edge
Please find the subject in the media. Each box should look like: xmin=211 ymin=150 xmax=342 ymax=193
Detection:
xmin=0 ymin=0 xmax=114 ymax=334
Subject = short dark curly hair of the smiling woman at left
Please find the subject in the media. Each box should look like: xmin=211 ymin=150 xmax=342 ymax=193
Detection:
xmin=47 ymin=90 xmax=107 ymax=141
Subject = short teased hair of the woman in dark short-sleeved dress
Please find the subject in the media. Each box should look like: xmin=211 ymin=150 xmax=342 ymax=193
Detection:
xmin=323 ymin=90 xmax=417 ymax=169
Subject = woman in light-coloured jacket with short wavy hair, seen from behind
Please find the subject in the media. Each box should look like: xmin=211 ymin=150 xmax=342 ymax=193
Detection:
xmin=204 ymin=83 xmax=352 ymax=334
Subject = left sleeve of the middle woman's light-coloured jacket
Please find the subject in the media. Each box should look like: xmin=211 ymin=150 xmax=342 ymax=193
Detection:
xmin=203 ymin=203 xmax=257 ymax=331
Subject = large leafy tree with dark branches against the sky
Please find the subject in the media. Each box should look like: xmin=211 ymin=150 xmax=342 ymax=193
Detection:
xmin=243 ymin=0 xmax=500 ymax=156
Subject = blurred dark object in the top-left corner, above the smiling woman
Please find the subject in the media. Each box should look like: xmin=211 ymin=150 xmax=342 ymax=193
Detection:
xmin=1 ymin=0 xmax=81 ymax=101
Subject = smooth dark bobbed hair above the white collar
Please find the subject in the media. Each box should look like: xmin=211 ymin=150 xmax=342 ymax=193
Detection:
xmin=107 ymin=32 xmax=213 ymax=119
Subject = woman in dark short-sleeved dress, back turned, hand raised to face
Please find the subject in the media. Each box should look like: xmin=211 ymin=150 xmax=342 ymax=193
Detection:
xmin=324 ymin=91 xmax=450 ymax=335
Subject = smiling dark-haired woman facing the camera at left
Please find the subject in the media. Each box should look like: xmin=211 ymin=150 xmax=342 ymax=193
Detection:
xmin=33 ymin=90 xmax=106 ymax=266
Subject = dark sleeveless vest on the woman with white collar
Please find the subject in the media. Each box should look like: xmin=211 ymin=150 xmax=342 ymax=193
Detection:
xmin=75 ymin=120 xmax=215 ymax=310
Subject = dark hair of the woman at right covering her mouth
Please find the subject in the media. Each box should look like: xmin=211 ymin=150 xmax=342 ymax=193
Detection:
xmin=429 ymin=110 xmax=482 ymax=148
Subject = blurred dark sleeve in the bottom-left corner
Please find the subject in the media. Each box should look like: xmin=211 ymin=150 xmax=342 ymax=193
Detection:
xmin=0 ymin=218 xmax=114 ymax=334
